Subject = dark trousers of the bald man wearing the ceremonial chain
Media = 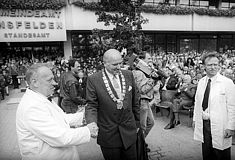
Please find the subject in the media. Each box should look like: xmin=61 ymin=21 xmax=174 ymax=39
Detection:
xmin=101 ymin=143 xmax=137 ymax=160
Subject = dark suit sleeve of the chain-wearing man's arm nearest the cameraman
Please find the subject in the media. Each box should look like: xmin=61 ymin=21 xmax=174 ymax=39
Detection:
xmin=131 ymin=73 xmax=140 ymax=128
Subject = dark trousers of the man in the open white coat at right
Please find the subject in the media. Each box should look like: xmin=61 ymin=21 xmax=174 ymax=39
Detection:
xmin=202 ymin=120 xmax=231 ymax=160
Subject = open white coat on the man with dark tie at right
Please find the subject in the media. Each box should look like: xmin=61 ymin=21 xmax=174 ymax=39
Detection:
xmin=193 ymin=73 xmax=235 ymax=150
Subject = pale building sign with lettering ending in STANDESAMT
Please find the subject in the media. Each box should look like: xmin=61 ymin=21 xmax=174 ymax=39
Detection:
xmin=0 ymin=9 xmax=66 ymax=42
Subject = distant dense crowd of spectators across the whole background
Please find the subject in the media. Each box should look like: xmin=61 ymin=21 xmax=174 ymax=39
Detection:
xmin=0 ymin=51 xmax=235 ymax=99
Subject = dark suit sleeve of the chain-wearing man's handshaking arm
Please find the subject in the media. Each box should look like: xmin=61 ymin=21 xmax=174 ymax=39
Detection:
xmin=85 ymin=77 xmax=98 ymax=123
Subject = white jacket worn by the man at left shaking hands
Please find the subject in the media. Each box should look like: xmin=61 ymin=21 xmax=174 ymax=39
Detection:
xmin=16 ymin=89 xmax=90 ymax=160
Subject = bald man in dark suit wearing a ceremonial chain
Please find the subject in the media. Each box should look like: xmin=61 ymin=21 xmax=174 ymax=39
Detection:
xmin=86 ymin=49 xmax=140 ymax=160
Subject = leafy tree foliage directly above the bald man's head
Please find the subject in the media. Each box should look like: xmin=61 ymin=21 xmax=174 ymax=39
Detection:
xmin=92 ymin=0 xmax=148 ymax=56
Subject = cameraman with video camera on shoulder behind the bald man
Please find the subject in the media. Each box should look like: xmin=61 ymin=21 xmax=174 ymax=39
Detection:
xmin=132 ymin=52 xmax=157 ymax=151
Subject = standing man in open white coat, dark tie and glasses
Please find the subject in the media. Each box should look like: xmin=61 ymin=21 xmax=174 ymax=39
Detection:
xmin=193 ymin=53 xmax=235 ymax=160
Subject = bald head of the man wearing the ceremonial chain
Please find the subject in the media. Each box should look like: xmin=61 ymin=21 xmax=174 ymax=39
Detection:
xmin=103 ymin=49 xmax=122 ymax=74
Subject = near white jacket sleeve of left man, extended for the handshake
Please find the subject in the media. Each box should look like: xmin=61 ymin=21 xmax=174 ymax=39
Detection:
xmin=23 ymin=104 xmax=90 ymax=147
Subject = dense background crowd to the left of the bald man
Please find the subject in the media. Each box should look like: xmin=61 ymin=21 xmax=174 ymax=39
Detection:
xmin=0 ymin=53 xmax=102 ymax=100
